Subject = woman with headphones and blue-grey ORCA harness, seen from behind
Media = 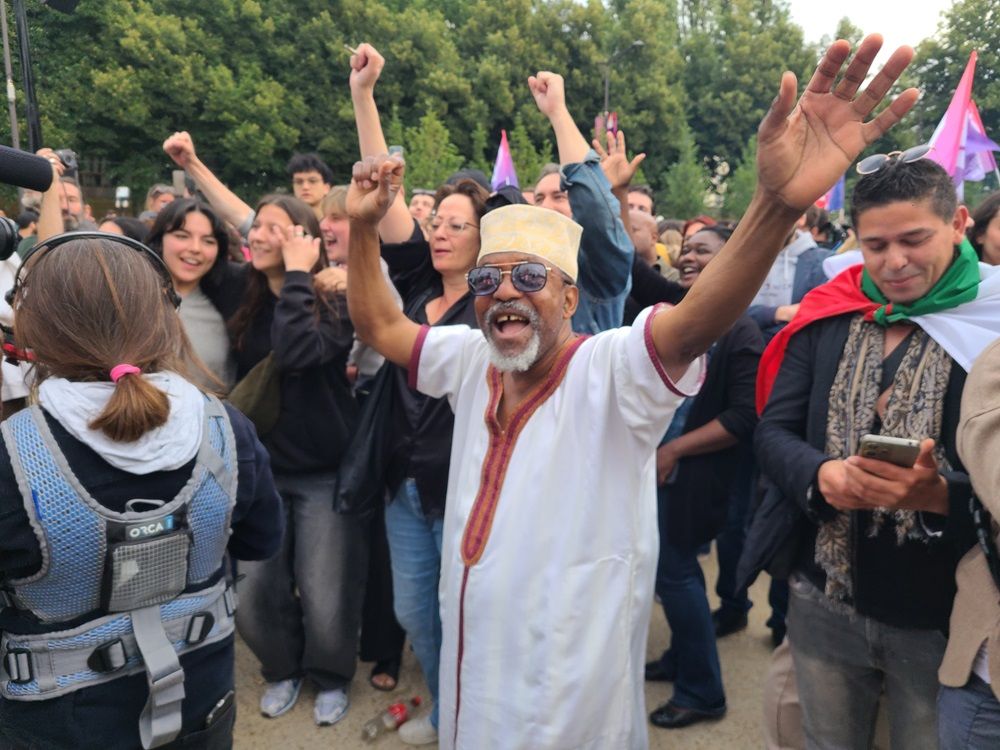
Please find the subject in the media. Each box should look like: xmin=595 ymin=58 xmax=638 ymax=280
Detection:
xmin=0 ymin=233 xmax=283 ymax=750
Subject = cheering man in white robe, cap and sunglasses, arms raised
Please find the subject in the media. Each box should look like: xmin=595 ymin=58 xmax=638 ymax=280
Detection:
xmin=348 ymin=37 xmax=916 ymax=750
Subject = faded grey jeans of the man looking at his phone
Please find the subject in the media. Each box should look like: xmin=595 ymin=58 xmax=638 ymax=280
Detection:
xmin=788 ymin=573 xmax=946 ymax=750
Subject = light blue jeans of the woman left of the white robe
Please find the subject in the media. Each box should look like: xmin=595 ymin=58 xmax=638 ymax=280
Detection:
xmin=385 ymin=479 xmax=444 ymax=727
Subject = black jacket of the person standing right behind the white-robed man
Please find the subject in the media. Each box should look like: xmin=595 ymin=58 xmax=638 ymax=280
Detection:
xmin=660 ymin=315 xmax=764 ymax=549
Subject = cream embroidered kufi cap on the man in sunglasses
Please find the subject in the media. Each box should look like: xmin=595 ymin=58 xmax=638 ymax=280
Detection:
xmin=477 ymin=205 xmax=583 ymax=283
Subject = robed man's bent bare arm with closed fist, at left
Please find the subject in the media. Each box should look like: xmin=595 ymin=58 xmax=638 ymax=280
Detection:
xmin=347 ymin=155 xmax=420 ymax=367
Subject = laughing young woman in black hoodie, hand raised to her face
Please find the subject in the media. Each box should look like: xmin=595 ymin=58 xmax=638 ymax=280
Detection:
xmin=222 ymin=195 xmax=367 ymax=725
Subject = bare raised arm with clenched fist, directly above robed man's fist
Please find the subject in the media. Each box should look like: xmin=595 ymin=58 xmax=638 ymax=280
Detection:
xmin=350 ymin=44 xmax=419 ymax=244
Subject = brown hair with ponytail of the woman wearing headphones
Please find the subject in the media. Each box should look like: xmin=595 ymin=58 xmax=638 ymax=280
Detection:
xmin=14 ymin=239 xmax=195 ymax=442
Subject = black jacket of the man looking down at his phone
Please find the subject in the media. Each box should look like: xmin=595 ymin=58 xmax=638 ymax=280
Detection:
xmin=751 ymin=315 xmax=975 ymax=630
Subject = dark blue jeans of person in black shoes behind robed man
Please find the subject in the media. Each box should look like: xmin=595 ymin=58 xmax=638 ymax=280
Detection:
xmin=656 ymin=490 xmax=726 ymax=711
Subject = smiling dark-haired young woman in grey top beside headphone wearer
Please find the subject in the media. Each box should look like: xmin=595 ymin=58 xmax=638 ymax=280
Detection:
xmin=147 ymin=198 xmax=236 ymax=391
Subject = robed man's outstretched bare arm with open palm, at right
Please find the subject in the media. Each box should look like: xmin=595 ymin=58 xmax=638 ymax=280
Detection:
xmin=653 ymin=34 xmax=918 ymax=377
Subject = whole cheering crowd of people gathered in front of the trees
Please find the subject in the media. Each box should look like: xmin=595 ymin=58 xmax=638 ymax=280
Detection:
xmin=0 ymin=29 xmax=1000 ymax=750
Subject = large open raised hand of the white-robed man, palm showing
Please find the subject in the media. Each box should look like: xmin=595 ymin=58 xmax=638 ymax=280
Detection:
xmin=757 ymin=34 xmax=919 ymax=212
